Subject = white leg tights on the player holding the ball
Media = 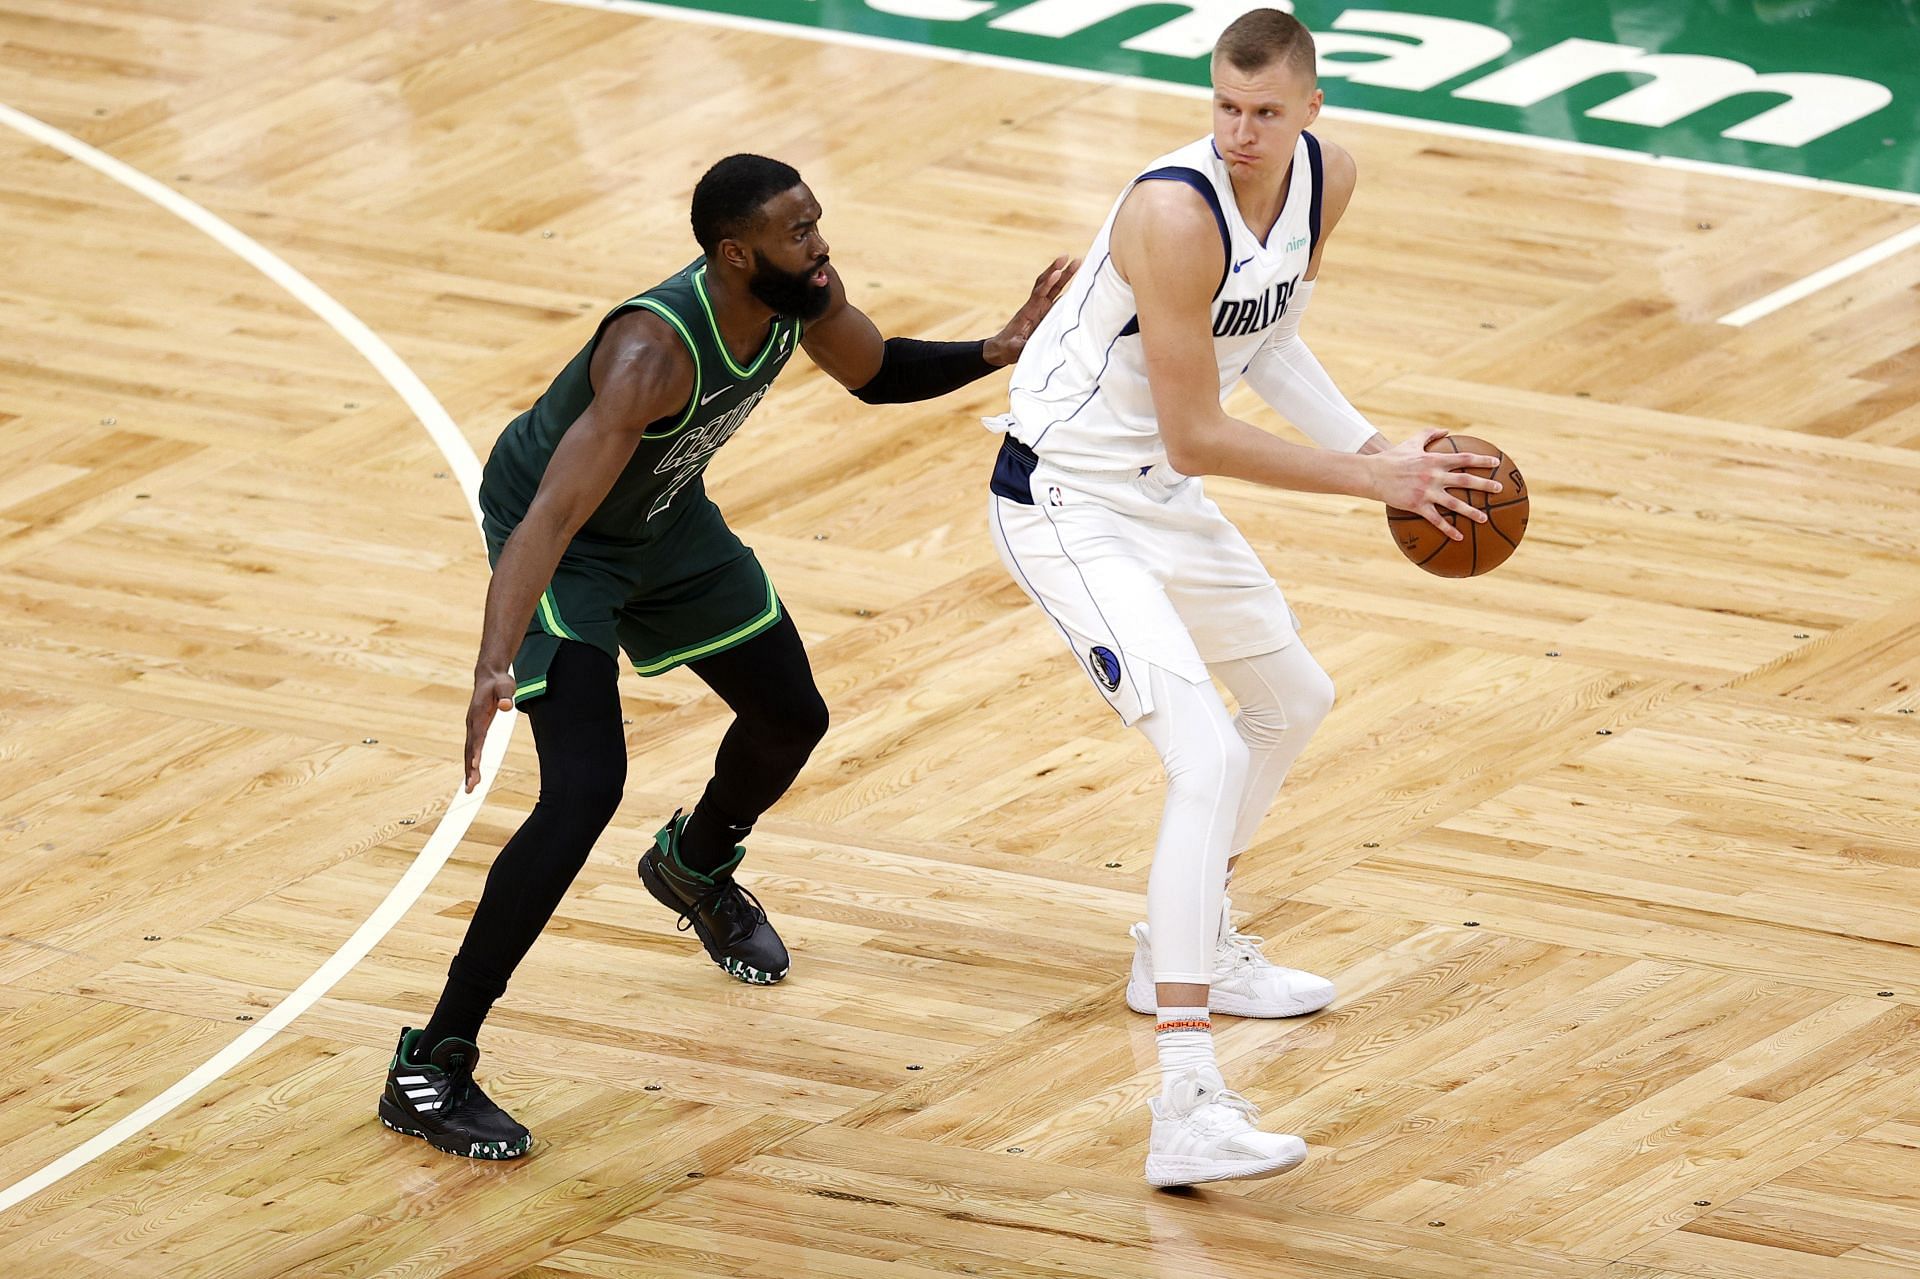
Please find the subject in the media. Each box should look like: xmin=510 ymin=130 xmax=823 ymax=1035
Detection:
xmin=1135 ymin=640 xmax=1332 ymax=985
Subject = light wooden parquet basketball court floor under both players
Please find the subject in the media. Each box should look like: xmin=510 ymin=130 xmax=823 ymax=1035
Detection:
xmin=0 ymin=0 xmax=1920 ymax=1279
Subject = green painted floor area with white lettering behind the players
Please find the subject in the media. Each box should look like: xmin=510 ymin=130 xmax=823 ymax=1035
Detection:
xmin=563 ymin=0 xmax=1920 ymax=192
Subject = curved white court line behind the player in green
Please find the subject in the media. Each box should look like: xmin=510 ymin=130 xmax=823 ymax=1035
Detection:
xmin=0 ymin=104 xmax=518 ymax=1212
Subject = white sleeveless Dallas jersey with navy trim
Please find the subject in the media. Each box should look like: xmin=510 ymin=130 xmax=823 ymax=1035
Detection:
xmin=1008 ymin=133 xmax=1321 ymax=471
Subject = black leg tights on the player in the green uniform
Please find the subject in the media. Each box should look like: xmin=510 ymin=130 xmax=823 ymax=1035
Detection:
xmin=420 ymin=613 xmax=828 ymax=1050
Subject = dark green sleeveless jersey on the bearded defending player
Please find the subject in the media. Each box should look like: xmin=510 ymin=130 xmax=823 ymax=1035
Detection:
xmin=480 ymin=257 xmax=803 ymax=543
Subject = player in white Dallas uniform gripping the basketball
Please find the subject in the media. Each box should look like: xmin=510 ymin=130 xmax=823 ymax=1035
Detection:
xmin=989 ymin=10 xmax=1500 ymax=1185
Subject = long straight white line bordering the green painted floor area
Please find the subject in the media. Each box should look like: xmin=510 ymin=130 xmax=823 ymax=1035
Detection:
xmin=541 ymin=0 xmax=1920 ymax=205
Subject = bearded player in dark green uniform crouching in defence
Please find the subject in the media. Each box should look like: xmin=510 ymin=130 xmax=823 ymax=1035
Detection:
xmin=380 ymin=156 xmax=1073 ymax=1160
